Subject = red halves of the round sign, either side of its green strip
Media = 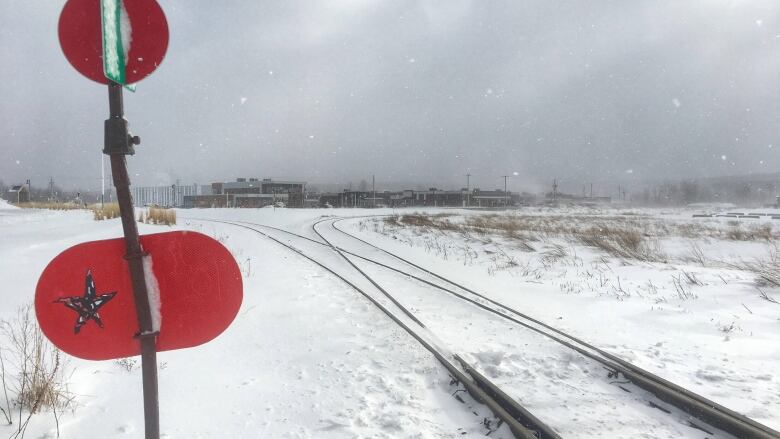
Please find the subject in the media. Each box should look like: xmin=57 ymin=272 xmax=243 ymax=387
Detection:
xmin=58 ymin=0 xmax=168 ymax=84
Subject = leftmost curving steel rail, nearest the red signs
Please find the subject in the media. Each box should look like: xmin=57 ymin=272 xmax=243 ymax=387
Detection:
xmin=201 ymin=218 xmax=561 ymax=439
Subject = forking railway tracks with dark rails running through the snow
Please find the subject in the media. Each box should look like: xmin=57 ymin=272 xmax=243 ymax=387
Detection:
xmin=190 ymin=218 xmax=780 ymax=439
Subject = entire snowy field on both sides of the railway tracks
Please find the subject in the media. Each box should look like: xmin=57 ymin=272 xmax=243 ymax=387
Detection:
xmin=0 ymin=201 xmax=780 ymax=438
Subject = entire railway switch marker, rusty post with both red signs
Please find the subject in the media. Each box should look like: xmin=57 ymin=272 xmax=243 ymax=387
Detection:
xmin=51 ymin=0 xmax=243 ymax=439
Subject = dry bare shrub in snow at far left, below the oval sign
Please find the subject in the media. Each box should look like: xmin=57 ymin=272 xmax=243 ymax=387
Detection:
xmin=0 ymin=305 xmax=73 ymax=437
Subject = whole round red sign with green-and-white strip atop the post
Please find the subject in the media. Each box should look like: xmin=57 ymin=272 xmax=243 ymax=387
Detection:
xmin=58 ymin=0 xmax=168 ymax=85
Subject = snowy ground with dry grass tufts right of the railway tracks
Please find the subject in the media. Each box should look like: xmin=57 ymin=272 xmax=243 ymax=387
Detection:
xmin=341 ymin=209 xmax=780 ymax=429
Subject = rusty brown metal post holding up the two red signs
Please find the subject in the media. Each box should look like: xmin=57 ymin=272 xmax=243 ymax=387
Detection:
xmin=103 ymin=82 xmax=160 ymax=439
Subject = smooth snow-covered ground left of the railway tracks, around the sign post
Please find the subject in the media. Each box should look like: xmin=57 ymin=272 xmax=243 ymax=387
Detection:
xmin=0 ymin=206 xmax=506 ymax=438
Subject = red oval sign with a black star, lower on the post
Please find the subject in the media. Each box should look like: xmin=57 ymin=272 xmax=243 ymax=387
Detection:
xmin=35 ymin=232 xmax=243 ymax=360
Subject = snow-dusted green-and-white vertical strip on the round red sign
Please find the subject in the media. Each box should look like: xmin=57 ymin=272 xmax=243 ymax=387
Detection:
xmin=100 ymin=0 xmax=127 ymax=85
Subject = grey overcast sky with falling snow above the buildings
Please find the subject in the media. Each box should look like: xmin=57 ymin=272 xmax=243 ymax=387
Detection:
xmin=0 ymin=0 xmax=780 ymax=194
